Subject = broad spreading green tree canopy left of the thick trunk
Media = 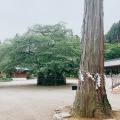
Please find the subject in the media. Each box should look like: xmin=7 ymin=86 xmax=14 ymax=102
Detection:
xmin=0 ymin=23 xmax=80 ymax=76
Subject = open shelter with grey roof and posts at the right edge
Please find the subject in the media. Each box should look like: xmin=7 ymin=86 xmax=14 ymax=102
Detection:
xmin=104 ymin=59 xmax=120 ymax=89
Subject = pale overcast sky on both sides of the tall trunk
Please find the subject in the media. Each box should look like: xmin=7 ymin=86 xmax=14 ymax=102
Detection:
xmin=0 ymin=0 xmax=120 ymax=40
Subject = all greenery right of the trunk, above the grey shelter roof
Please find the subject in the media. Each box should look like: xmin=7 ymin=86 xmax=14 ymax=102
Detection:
xmin=104 ymin=21 xmax=120 ymax=60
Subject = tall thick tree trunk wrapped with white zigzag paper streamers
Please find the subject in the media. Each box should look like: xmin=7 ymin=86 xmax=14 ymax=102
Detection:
xmin=72 ymin=0 xmax=111 ymax=118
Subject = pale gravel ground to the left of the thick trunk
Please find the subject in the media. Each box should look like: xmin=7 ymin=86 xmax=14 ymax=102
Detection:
xmin=0 ymin=80 xmax=77 ymax=120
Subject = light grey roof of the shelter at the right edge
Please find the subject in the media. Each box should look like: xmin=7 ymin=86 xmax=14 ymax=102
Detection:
xmin=104 ymin=59 xmax=120 ymax=68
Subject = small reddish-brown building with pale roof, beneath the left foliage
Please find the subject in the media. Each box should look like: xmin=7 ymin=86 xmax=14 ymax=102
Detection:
xmin=11 ymin=67 xmax=28 ymax=80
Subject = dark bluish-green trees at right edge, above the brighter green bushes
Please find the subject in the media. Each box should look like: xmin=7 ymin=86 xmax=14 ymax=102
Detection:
xmin=105 ymin=21 xmax=120 ymax=43
